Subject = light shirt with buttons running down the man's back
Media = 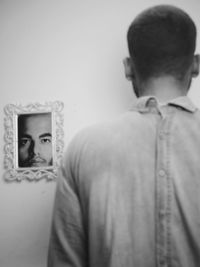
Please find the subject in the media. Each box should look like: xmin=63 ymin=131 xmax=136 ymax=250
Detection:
xmin=48 ymin=97 xmax=200 ymax=267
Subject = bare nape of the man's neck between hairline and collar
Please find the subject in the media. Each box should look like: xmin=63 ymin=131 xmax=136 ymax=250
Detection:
xmin=140 ymin=77 xmax=188 ymax=103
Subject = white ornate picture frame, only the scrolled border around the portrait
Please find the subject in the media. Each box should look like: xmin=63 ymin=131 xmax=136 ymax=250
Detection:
xmin=4 ymin=101 xmax=64 ymax=181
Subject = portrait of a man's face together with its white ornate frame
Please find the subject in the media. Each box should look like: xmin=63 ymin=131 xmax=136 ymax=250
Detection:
xmin=4 ymin=101 xmax=64 ymax=181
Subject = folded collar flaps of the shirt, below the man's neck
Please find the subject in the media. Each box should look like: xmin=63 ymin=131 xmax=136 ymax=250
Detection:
xmin=133 ymin=96 xmax=197 ymax=113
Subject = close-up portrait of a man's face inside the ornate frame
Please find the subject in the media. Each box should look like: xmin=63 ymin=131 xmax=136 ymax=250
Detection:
xmin=18 ymin=113 xmax=53 ymax=167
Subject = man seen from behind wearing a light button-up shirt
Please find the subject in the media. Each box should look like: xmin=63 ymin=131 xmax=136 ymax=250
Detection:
xmin=48 ymin=6 xmax=200 ymax=267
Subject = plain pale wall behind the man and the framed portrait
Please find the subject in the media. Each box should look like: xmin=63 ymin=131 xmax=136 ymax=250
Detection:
xmin=0 ymin=0 xmax=200 ymax=267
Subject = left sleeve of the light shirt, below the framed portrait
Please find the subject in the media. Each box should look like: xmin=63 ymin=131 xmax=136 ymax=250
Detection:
xmin=47 ymin=138 xmax=88 ymax=267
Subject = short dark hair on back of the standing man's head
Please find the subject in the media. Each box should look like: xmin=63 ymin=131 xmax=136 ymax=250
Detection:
xmin=127 ymin=5 xmax=196 ymax=80
